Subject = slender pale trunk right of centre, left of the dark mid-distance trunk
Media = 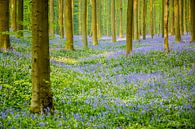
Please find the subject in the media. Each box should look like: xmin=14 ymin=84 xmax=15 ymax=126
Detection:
xmin=111 ymin=0 xmax=116 ymax=42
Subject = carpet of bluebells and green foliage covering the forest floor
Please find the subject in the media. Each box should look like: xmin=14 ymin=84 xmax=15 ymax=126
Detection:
xmin=0 ymin=35 xmax=195 ymax=129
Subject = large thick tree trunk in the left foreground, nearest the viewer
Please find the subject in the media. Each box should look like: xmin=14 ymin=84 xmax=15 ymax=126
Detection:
xmin=30 ymin=0 xmax=54 ymax=113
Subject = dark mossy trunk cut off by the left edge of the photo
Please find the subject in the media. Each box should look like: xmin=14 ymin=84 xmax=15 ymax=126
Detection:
xmin=0 ymin=0 xmax=10 ymax=50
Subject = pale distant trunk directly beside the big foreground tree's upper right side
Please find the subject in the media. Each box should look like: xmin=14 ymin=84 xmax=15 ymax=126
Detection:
xmin=49 ymin=0 xmax=54 ymax=37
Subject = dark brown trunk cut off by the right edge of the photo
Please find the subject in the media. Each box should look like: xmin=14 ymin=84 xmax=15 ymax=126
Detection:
xmin=190 ymin=0 xmax=195 ymax=43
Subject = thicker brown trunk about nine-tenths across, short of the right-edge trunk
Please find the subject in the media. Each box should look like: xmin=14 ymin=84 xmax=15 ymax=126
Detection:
xmin=174 ymin=0 xmax=181 ymax=43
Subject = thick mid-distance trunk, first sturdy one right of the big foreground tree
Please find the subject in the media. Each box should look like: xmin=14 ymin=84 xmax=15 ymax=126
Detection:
xmin=65 ymin=0 xmax=74 ymax=50
